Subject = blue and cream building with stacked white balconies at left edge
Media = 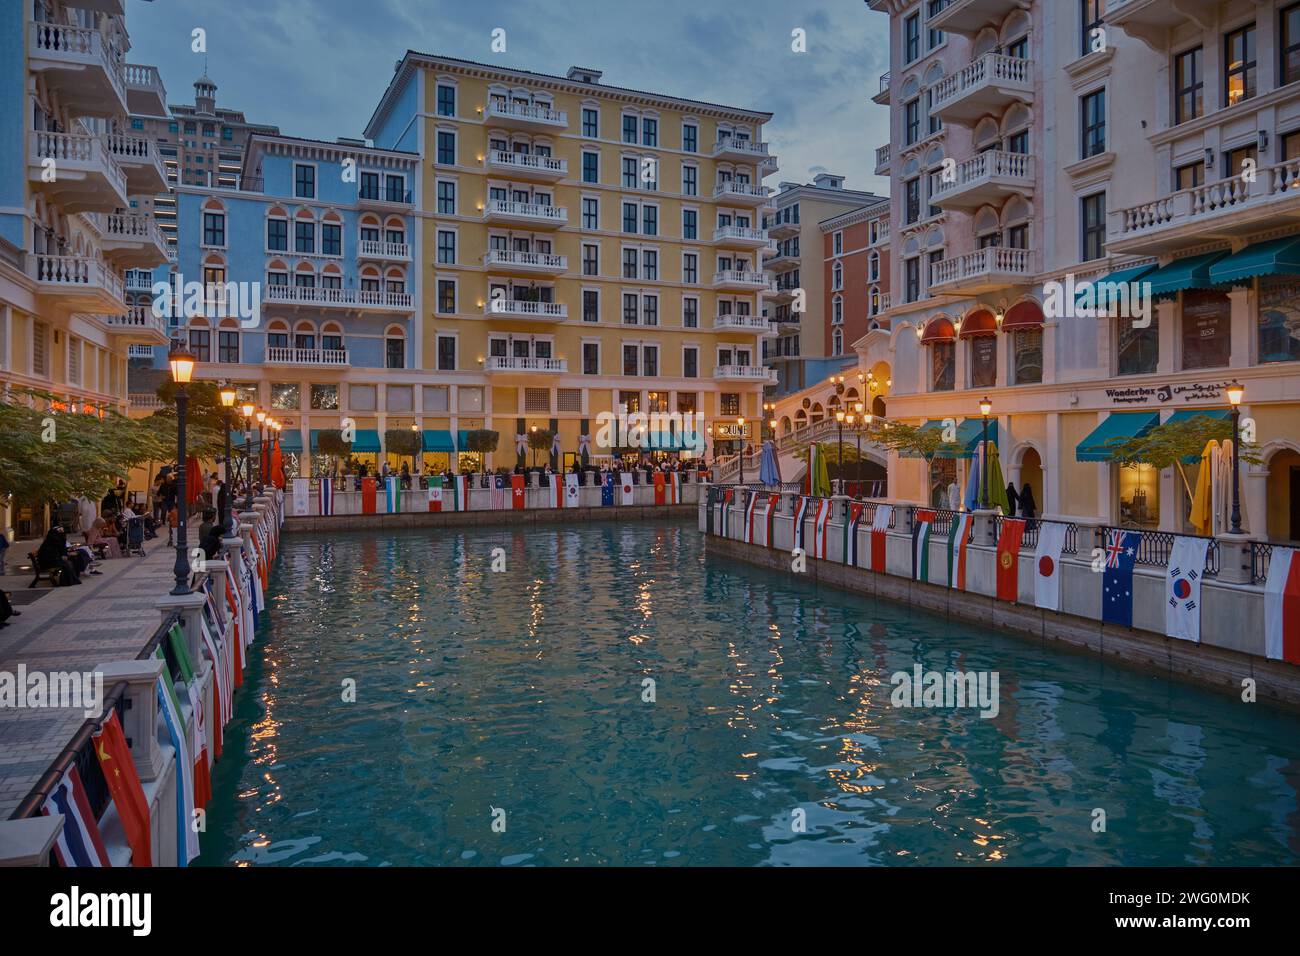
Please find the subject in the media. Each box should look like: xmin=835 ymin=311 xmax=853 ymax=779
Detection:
xmin=0 ymin=0 xmax=166 ymax=525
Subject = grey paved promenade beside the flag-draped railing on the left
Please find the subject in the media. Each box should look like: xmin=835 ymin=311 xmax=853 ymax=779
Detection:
xmin=0 ymin=537 xmax=176 ymax=819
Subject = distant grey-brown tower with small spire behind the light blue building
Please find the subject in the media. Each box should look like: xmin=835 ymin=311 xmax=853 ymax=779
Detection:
xmin=131 ymin=70 xmax=280 ymax=243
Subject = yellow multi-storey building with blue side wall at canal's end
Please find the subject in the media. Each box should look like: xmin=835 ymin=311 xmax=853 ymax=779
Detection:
xmin=365 ymin=52 xmax=772 ymax=464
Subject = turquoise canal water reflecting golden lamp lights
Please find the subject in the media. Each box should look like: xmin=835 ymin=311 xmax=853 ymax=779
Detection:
xmin=198 ymin=524 xmax=1300 ymax=865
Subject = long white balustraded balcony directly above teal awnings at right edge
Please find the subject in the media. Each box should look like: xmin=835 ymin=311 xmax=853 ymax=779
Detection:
xmin=1106 ymin=160 xmax=1300 ymax=255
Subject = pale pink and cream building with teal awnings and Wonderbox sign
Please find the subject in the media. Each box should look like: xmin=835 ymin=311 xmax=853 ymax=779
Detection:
xmin=858 ymin=0 xmax=1300 ymax=541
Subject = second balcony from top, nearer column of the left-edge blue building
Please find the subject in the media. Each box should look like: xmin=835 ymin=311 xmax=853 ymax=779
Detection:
xmin=27 ymin=130 xmax=129 ymax=212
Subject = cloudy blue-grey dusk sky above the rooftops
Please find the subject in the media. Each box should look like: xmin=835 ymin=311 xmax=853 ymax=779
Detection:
xmin=126 ymin=0 xmax=889 ymax=193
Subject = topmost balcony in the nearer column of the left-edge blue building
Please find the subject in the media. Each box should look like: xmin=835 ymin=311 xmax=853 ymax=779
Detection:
xmin=28 ymin=21 xmax=127 ymax=117
